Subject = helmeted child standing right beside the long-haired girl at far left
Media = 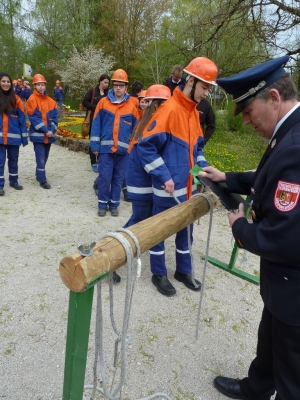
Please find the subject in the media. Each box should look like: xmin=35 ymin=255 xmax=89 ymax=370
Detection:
xmin=27 ymin=74 xmax=58 ymax=189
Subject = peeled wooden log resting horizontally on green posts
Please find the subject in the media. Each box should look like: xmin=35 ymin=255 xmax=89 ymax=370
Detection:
xmin=59 ymin=192 xmax=220 ymax=292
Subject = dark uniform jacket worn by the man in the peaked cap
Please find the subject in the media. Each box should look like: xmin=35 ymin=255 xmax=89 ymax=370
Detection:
xmin=226 ymin=107 xmax=300 ymax=325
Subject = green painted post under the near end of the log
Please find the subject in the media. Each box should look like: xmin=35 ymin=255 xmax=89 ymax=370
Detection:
xmin=63 ymin=286 xmax=94 ymax=400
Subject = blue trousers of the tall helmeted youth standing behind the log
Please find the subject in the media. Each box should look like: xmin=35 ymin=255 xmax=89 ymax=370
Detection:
xmin=149 ymin=203 xmax=193 ymax=275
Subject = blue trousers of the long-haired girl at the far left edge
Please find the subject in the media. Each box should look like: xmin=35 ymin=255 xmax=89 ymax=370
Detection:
xmin=0 ymin=144 xmax=20 ymax=189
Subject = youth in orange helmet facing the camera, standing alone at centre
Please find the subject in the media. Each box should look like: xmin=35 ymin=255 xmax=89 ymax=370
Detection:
xmin=90 ymin=69 xmax=139 ymax=217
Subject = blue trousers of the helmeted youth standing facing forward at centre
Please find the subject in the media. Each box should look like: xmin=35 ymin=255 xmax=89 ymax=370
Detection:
xmin=98 ymin=153 xmax=128 ymax=209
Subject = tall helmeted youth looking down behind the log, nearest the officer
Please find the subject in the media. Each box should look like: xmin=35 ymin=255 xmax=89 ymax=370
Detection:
xmin=137 ymin=57 xmax=218 ymax=296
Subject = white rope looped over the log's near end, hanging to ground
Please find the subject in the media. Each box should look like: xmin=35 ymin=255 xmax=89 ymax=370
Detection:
xmin=84 ymin=228 xmax=172 ymax=400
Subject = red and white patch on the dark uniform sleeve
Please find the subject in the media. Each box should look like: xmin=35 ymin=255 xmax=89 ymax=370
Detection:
xmin=274 ymin=181 xmax=300 ymax=212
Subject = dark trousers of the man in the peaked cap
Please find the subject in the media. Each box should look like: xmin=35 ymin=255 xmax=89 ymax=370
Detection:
xmin=239 ymin=307 xmax=300 ymax=400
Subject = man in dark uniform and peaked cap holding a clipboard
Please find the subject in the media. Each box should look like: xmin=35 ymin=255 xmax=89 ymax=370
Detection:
xmin=203 ymin=56 xmax=300 ymax=400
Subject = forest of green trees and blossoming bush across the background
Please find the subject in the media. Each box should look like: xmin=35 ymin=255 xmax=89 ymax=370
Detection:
xmin=0 ymin=0 xmax=300 ymax=98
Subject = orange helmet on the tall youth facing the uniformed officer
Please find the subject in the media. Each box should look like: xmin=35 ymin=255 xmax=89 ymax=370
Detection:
xmin=183 ymin=57 xmax=218 ymax=85
